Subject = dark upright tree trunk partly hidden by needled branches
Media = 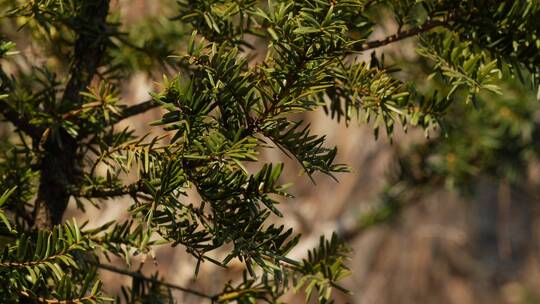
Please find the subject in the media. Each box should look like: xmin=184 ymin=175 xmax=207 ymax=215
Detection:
xmin=34 ymin=0 xmax=109 ymax=229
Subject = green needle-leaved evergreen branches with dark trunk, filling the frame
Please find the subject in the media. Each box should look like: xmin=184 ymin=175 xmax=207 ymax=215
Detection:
xmin=0 ymin=0 xmax=540 ymax=303
